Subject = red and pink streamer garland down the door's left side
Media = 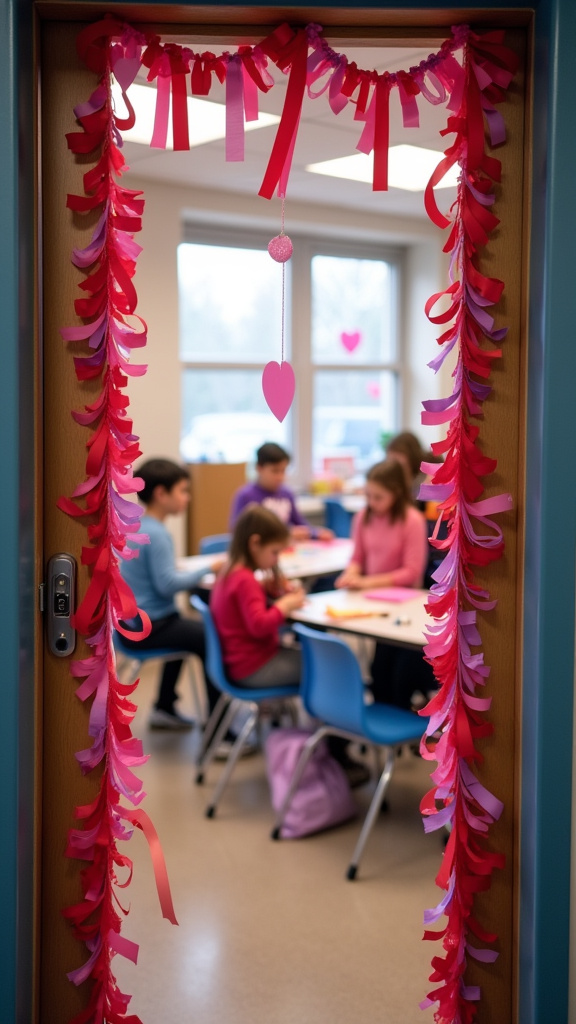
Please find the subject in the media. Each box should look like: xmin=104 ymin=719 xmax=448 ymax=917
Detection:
xmin=58 ymin=17 xmax=177 ymax=1024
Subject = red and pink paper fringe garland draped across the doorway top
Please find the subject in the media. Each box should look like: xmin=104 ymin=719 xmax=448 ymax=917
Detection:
xmin=78 ymin=15 xmax=477 ymax=199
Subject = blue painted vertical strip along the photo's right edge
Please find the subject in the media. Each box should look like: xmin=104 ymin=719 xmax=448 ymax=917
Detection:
xmin=520 ymin=0 xmax=576 ymax=1024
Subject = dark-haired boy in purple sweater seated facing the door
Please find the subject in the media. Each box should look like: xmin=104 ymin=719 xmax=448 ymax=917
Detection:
xmin=230 ymin=441 xmax=334 ymax=541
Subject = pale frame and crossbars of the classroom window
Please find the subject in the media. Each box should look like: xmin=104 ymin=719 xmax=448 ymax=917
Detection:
xmin=178 ymin=217 xmax=408 ymax=489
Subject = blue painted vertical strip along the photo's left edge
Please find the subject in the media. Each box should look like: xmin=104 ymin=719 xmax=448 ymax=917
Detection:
xmin=0 ymin=2 xmax=37 ymax=1024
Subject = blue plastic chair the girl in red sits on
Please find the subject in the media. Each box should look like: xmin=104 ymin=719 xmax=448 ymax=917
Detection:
xmin=191 ymin=594 xmax=300 ymax=818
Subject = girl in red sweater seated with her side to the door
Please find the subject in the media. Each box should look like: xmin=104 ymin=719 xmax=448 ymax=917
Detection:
xmin=210 ymin=504 xmax=305 ymax=688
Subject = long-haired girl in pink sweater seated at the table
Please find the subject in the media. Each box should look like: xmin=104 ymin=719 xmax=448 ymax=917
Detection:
xmin=336 ymin=460 xmax=436 ymax=708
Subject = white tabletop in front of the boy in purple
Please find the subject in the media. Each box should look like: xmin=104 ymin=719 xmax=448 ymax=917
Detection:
xmin=176 ymin=538 xmax=353 ymax=586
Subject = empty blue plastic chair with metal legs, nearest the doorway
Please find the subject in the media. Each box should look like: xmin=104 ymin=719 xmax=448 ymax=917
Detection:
xmin=272 ymin=625 xmax=426 ymax=881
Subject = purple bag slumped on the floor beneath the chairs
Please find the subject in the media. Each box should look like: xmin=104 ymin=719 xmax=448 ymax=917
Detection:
xmin=265 ymin=729 xmax=358 ymax=839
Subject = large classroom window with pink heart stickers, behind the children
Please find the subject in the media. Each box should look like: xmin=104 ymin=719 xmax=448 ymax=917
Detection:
xmin=178 ymin=224 xmax=403 ymax=487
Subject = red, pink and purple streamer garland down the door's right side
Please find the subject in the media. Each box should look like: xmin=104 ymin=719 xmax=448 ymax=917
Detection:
xmin=414 ymin=32 xmax=517 ymax=1024
